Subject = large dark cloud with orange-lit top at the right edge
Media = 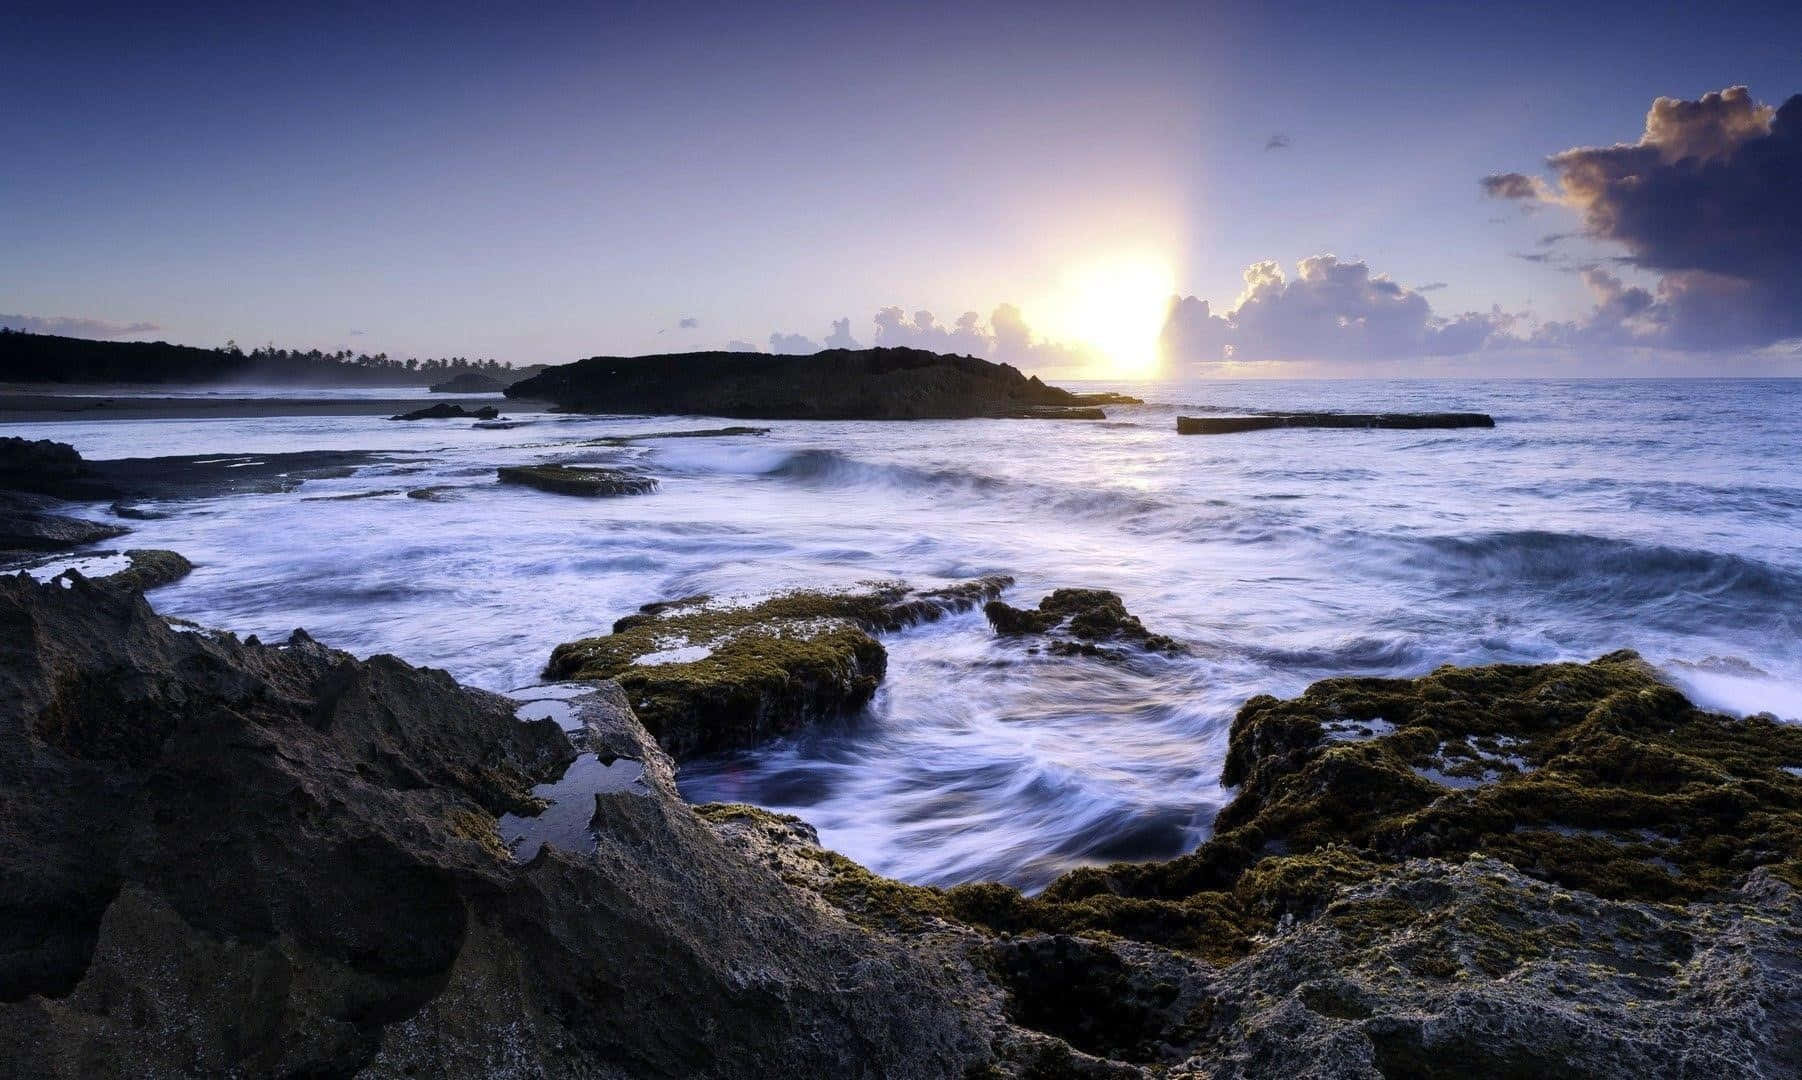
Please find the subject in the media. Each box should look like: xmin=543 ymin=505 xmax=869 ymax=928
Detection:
xmin=1483 ymin=87 xmax=1802 ymax=350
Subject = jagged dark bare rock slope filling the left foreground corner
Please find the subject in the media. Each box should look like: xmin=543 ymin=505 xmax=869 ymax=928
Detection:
xmin=0 ymin=577 xmax=986 ymax=1078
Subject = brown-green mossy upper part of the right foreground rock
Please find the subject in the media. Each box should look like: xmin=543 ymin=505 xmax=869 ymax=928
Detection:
xmin=840 ymin=649 xmax=1802 ymax=974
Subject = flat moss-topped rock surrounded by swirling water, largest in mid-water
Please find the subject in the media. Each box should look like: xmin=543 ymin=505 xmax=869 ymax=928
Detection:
xmin=544 ymin=577 xmax=1011 ymax=759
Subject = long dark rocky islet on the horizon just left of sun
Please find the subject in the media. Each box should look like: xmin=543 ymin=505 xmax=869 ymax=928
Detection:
xmin=506 ymin=348 xmax=1137 ymax=420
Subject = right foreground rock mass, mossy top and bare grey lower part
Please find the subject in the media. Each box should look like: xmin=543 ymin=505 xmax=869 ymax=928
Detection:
xmin=800 ymin=653 xmax=1802 ymax=1080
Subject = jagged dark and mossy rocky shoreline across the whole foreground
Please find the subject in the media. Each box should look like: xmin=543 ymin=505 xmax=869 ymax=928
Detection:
xmin=0 ymin=575 xmax=1802 ymax=1078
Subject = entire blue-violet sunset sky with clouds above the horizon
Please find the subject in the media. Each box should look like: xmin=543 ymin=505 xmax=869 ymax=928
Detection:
xmin=0 ymin=2 xmax=1802 ymax=375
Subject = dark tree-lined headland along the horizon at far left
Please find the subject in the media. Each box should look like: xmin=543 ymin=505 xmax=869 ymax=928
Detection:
xmin=0 ymin=326 xmax=542 ymax=386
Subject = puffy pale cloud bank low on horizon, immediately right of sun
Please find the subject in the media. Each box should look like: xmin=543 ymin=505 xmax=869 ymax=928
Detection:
xmin=1160 ymin=254 xmax=1512 ymax=364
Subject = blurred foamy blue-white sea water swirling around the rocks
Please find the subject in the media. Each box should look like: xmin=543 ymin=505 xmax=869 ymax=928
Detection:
xmin=7 ymin=380 xmax=1802 ymax=887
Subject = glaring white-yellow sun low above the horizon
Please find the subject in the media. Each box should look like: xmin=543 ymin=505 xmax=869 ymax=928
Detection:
xmin=1060 ymin=252 xmax=1177 ymax=379
